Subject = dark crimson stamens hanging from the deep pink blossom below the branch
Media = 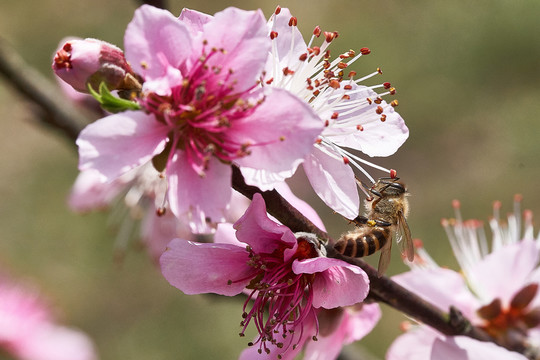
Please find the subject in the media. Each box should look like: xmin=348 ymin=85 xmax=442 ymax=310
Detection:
xmin=240 ymin=238 xmax=318 ymax=358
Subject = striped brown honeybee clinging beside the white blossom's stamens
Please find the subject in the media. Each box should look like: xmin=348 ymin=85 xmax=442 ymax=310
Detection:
xmin=334 ymin=178 xmax=414 ymax=276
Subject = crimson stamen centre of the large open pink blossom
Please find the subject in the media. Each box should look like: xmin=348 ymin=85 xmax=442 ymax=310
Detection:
xmin=141 ymin=44 xmax=264 ymax=176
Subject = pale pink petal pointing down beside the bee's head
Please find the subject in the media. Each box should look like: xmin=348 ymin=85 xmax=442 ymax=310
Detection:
xmin=303 ymin=147 xmax=360 ymax=219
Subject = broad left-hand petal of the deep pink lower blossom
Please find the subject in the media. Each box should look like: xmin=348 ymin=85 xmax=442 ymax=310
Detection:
xmin=160 ymin=239 xmax=254 ymax=296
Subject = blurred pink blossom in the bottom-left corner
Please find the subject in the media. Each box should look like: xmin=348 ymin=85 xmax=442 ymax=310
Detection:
xmin=0 ymin=275 xmax=97 ymax=360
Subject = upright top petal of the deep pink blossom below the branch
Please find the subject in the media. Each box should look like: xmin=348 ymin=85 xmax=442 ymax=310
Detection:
xmin=234 ymin=193 xmax=297 ymax=253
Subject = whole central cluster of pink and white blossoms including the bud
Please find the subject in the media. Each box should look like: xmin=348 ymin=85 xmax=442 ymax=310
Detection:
xmin=52 ymin=5 xmax=414 ymax=359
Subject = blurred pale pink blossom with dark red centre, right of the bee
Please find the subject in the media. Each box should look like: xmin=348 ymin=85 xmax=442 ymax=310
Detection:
xmin=387 ymin=197 xmax=540 ymax=360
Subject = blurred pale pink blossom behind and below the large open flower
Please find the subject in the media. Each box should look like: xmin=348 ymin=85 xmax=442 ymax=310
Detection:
xmin=68 ymin=163 xmax=250 ymax=261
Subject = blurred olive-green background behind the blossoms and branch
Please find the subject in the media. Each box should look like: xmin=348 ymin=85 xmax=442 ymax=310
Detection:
xmin=0 ymin=0 xmax=540 ymax=360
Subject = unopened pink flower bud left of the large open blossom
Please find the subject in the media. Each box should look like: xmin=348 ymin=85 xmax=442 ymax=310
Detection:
xmin=52 ymin=39 xmax=140 ymax=93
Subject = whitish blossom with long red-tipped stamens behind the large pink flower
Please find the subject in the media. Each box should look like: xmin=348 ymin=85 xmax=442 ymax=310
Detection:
xmin=238 ymin=7 xmax=409 ymax=219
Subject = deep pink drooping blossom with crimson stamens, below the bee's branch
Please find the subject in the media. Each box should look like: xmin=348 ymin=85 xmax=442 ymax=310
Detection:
xmin=160 ymin=194 xmax=369 ymax=356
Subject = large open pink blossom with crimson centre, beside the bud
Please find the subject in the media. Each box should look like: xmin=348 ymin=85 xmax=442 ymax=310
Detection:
xmin=77 ymin=5 xmax=322 ymax=228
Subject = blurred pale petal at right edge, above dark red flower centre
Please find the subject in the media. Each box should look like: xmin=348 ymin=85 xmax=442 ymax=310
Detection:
xmin=471 ymin=240 xmax=539 ymax=303
